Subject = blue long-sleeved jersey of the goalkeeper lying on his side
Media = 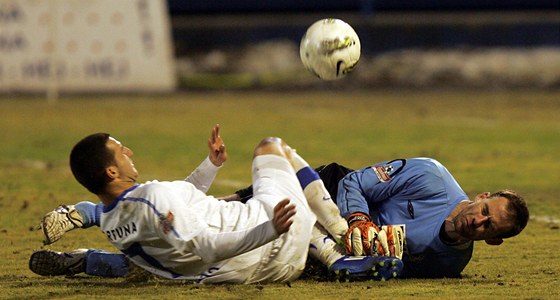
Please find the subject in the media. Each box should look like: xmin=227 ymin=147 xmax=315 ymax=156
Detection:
xmin=337 ymin=158 xmax=473 ymax=277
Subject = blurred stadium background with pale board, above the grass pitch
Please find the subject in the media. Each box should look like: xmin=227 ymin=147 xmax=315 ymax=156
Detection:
xmin=0 ymin=0 xmax=560 ymax=97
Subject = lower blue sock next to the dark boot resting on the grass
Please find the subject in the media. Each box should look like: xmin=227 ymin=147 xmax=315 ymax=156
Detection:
xmin=85 ymin=249 xmax=129 ymax=277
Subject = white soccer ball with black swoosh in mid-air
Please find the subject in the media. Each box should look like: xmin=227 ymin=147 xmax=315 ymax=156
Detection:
xmin=299 ymin=19 xmax=360 ymax=80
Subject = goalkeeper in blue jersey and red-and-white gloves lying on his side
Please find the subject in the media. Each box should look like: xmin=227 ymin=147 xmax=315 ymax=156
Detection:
xmin=337 ymin=158 xmax=529 ymax=277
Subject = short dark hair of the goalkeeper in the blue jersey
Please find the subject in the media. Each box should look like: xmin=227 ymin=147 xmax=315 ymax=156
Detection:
xmin=489 ymin=190 xmax=529 ymax=239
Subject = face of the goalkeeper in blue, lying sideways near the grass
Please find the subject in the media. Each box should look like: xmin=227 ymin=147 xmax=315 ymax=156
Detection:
xmin=452 ymin=194 xmax=513 ymax=241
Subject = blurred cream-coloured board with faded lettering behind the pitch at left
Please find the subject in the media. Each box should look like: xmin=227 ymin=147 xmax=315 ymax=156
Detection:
xmin=0 ymin=0 xmax=176 ymax=95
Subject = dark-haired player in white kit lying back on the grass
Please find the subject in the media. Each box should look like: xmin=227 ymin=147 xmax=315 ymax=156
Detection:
xmin=30 ymin=129 xmax=402 ymax=283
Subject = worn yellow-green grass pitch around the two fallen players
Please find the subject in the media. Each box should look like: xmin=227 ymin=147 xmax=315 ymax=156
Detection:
xmin=0 ymin=91 xmax=560 ymax=299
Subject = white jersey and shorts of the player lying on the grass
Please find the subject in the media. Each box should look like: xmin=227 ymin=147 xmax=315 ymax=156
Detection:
xmin=101 ymin=155 xmax=315 ymax=283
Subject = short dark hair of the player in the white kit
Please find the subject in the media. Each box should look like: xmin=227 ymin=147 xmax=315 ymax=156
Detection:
xmin=70 ymin=133 xmax=115 ymax=195
